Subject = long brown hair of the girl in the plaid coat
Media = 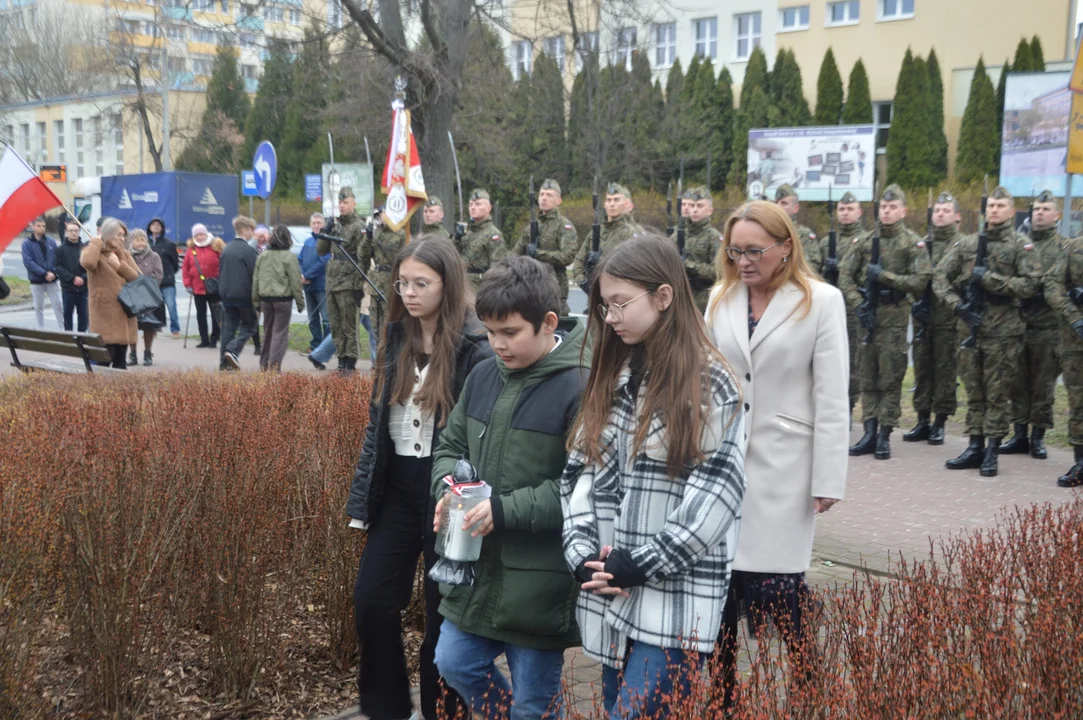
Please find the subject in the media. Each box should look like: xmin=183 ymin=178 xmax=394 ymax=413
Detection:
xmin=569 ymin=234 xmax=729 ymax=477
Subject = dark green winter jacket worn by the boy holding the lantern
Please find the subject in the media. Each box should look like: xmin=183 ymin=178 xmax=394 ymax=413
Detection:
xmin=432 ymin=319 xmax=590 ymax=650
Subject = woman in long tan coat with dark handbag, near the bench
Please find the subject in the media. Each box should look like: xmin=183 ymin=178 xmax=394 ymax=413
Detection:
xmin=79 ymin=218 xmax=139 ymax=370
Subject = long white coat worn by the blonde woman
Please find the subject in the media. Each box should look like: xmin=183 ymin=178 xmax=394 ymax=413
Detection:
xmin=706 ymin=280 xmax=850 ymax=573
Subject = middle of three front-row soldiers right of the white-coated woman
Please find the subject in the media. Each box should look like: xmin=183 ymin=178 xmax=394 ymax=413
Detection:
xmin=932 ymin=187 xmax=1042 ymax=477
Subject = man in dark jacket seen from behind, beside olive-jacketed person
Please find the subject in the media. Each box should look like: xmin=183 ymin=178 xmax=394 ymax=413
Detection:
xmin=218 ymin=215 xmax=260 ymax=370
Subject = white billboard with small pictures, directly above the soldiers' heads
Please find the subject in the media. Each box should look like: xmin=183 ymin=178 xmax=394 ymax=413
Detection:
xmin=747 ymin=125 xmax=876 ymax=202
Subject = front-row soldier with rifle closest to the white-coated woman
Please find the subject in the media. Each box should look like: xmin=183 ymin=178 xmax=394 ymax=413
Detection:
xmin=838 ymin=185 xmax=932 ymax=460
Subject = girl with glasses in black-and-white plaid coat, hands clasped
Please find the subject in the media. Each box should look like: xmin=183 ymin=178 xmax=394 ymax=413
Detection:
xmin=561 ymin=235 xmax=745 ymax=718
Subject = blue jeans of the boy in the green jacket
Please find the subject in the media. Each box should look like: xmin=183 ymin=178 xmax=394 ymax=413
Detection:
xmin=436 ymin=619 xmax=564 ymax=720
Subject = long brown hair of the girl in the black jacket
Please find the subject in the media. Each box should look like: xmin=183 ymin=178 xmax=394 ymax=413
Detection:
xmin=374 ymin=235 xmax=473 ymax=427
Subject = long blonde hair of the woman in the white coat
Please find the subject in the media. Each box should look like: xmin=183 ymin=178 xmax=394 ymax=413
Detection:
xmin=707 ymin=200 xmax=819 ymax=318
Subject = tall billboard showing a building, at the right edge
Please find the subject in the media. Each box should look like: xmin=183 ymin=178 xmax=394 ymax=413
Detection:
xmin=1000 ymin=71 xmax=1083 ymax=197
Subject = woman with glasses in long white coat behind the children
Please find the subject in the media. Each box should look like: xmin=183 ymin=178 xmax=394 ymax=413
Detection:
xmin=706 ymin=201 xmax=850 ymax=702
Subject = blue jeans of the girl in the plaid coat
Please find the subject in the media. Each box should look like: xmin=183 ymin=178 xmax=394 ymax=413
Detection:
xmin=602 ymin=641 xmax=707 ymax=720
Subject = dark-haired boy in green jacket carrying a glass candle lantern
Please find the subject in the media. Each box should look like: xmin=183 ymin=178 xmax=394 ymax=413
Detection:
xmin=432 ymin=257 xmax=590 ymax=720
